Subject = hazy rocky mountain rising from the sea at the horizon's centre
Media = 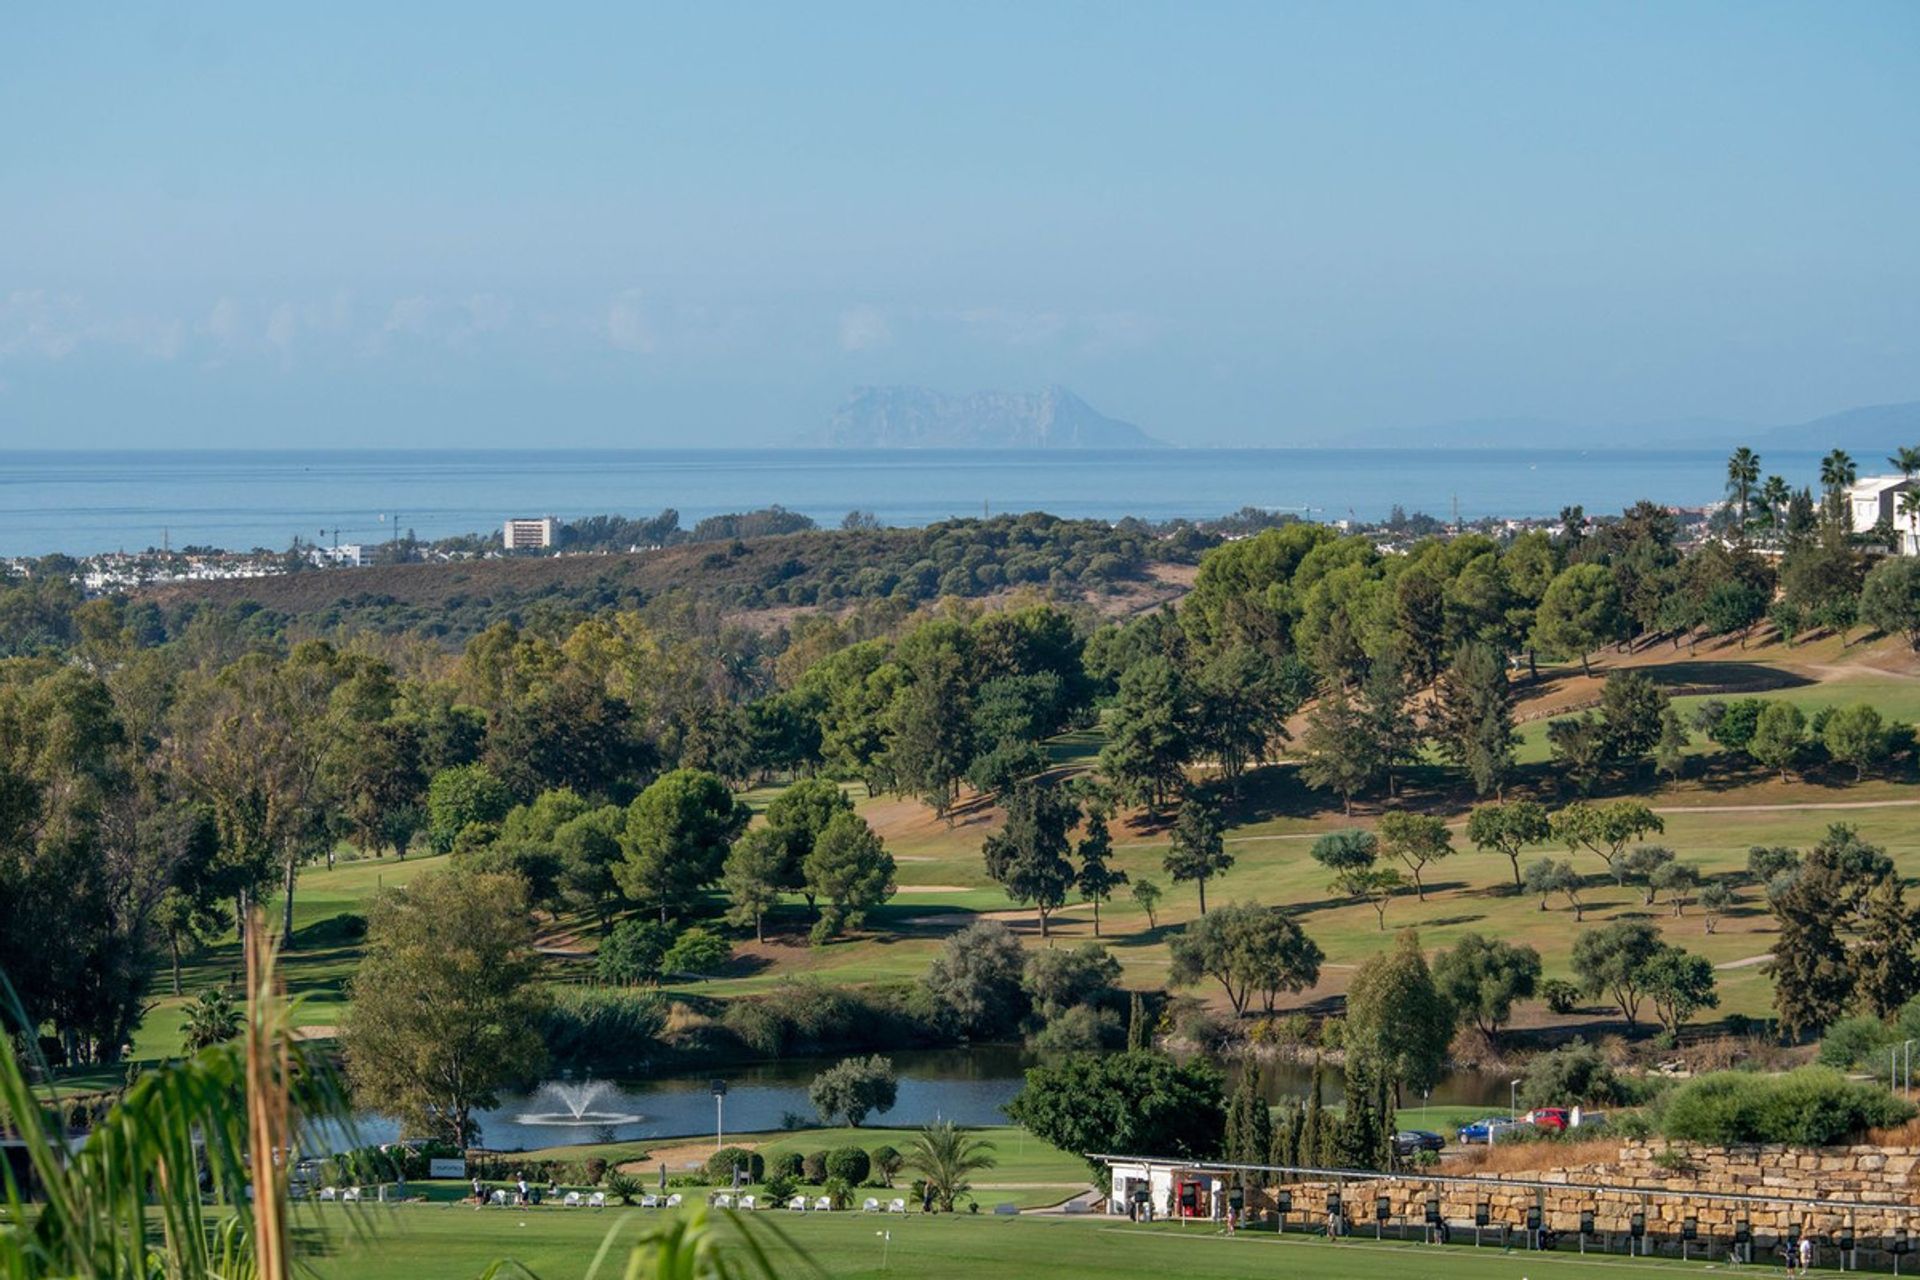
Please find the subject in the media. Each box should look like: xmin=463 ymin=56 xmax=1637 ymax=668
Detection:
xmin=806 ymin=386 xmax=1164 ymax=449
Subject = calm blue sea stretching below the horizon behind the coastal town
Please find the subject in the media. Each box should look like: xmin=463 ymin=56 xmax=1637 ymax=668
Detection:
xmin=0 ymin=449 xmax=1816 ymax=555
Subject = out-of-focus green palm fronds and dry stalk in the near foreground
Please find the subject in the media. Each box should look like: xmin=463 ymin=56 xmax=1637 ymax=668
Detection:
xmin=0 ymin=915 xmax=824 ymax=1280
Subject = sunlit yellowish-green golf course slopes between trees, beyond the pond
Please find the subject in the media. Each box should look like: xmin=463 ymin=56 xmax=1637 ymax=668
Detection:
xmin=115 ymin=633 xmax=1920 ymax=1075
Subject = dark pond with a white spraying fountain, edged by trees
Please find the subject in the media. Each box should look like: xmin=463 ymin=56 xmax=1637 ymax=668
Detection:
xmin=345 ymin=1044 xmax=1507 ymax=1151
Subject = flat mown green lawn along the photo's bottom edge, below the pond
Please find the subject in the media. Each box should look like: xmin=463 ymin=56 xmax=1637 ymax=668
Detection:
xmin=300 ymin=1205 xmax=1766 ymax=1280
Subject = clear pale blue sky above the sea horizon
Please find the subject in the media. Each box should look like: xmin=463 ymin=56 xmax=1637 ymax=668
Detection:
xmin=0 ymin=0 xmax=1920 ymax=447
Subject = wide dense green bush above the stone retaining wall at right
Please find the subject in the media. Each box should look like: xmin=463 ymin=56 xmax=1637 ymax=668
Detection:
xmin=1661 ymin=1067 xmax=1914 ymax=1146
